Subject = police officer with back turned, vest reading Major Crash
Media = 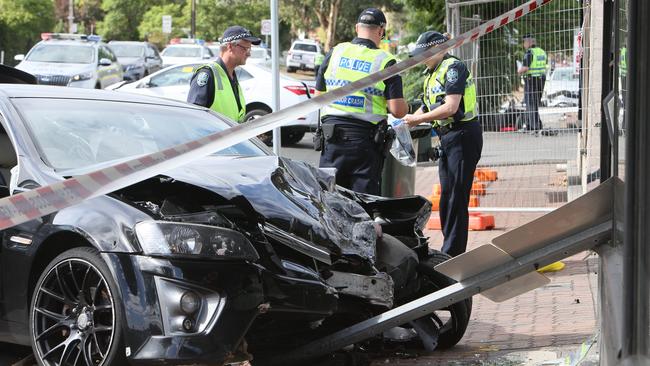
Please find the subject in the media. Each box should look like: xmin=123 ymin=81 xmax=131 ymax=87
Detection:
xmin=316 ymin=8 xmax=408 ymax=195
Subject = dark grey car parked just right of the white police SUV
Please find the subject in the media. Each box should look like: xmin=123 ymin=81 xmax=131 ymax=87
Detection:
xmin=108 ymin=41 xmax=162 ymax=80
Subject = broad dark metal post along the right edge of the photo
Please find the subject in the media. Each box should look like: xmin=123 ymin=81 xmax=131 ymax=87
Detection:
xmin=622 ymin=0 xmax=650 ymax=365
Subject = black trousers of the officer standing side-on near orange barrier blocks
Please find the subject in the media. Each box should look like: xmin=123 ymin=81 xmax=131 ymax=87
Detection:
xmin=438 ymin=121 xmax=483 ymax=257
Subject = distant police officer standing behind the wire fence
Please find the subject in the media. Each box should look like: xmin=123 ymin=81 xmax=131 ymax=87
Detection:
xmin=517 ymin=34 xmax=548 ymax=131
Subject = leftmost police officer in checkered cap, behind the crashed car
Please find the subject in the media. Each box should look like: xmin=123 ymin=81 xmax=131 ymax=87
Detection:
xmin=187 ymin=25 xmax=262 ymax=122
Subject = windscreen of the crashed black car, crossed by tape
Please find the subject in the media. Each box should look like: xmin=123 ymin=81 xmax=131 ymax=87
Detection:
xmin=15 ymin=98 xmax=266 ymax=174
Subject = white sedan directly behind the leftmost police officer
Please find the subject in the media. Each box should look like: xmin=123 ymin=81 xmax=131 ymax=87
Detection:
xmin=110 ymin=63 xmax=318 ymax=145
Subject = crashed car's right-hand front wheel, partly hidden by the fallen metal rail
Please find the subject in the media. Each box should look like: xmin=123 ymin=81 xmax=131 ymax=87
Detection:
xmin=398 ymin=249 xmax=472 ymax=349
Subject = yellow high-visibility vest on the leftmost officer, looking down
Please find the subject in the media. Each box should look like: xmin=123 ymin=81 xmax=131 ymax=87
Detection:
xmin=196 ymin=62 xmax=246 ymax=123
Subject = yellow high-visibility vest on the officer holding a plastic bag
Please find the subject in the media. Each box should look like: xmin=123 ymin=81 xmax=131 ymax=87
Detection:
xmin=424 ymin=57 xmax=477 ymax=126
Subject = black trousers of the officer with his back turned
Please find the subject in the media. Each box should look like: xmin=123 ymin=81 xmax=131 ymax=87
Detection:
xmin=319 ymin=121 xmax=384 ymax=195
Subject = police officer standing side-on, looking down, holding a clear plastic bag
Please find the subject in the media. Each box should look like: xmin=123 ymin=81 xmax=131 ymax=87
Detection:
xmin=404 ymin=31 xmax=483 ymax=256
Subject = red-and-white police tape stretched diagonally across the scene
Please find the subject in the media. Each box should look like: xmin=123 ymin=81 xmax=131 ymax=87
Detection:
xmin=0 ymin=0 xmax=553 ymax=230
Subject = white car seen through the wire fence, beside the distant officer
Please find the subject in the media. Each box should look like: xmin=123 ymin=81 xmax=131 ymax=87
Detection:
xmin=542 ymin=67 xmax=580 ymax=107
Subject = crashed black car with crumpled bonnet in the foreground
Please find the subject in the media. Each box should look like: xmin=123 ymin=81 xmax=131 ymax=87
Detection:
xmin=0 ymin=84 xmax=471 ymax=366
